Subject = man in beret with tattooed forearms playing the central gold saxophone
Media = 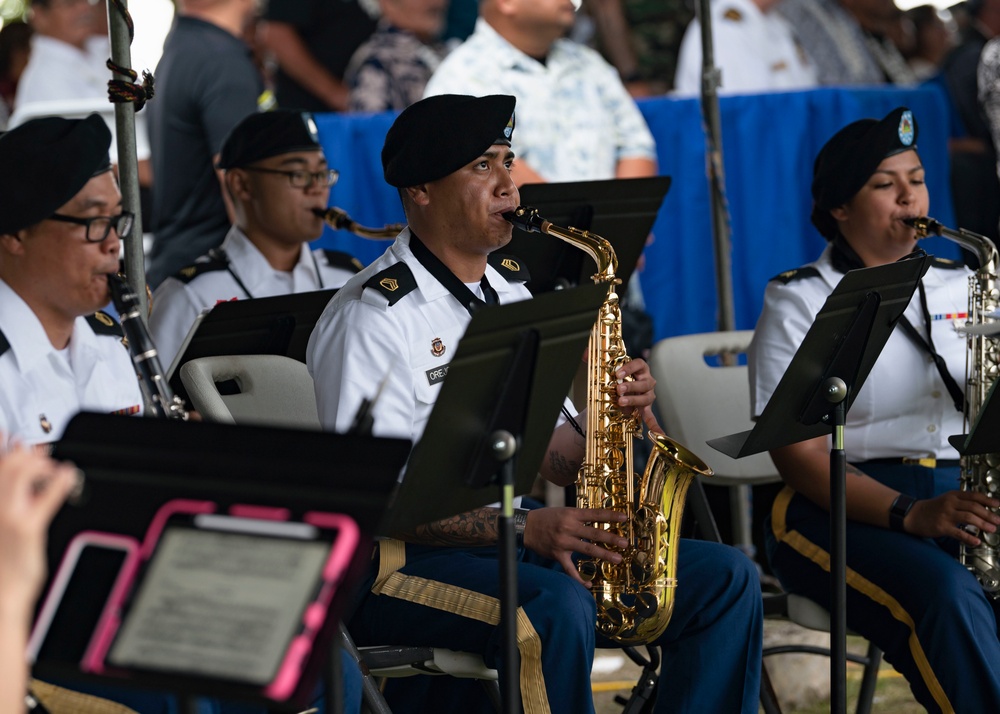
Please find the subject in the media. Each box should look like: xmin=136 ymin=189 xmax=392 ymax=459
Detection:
xmin=307 ymin=95 xmax=762 ymax=714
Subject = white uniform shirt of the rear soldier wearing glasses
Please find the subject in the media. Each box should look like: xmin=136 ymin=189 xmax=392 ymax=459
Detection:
xmin=149 ymin=226 xmax=361 ymax=368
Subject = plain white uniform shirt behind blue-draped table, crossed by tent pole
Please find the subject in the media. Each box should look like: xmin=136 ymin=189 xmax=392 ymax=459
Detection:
xmin=674 ymin=0 xmax=816 ymax=96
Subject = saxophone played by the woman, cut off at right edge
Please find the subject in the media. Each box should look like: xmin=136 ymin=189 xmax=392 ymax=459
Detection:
xmin=905 ymin=218 xmax=1000 ymax=599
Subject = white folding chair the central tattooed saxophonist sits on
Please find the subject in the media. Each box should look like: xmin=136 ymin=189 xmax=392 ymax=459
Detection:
xmin=180 ymin=355 xmax=500 ymax=714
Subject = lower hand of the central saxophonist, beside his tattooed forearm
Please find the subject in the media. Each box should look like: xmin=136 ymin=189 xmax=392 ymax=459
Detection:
xmin=524 ymin=507 xmax=628 ymax=588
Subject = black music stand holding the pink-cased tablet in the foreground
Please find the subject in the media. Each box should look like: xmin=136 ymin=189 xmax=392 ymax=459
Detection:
xmin=35 ymin=413 xmax=410 ymax=713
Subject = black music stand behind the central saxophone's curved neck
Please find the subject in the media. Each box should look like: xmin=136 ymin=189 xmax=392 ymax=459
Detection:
xmin=504 ymin=176 xmax=670 ymax=296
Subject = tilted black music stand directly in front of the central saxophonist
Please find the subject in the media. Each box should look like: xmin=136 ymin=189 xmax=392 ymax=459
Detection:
xmin=376 ymin=285 xmax=607 ymax=714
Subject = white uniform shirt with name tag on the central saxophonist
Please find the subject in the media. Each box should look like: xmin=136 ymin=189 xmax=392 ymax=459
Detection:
xmin=306 ymin=228 xmax=531 ymax=443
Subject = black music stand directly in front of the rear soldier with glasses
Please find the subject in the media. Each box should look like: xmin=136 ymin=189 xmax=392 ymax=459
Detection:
xmin=167 ymin=290 xmax=337 ymax=404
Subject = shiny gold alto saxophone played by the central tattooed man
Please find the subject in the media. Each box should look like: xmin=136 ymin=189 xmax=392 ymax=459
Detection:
xmin=504 ymin=206 xmax=713 ymax=645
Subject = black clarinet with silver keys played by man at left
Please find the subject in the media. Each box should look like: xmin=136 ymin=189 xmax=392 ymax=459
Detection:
xmin=108 ymin=274 xmax=188 ymax=419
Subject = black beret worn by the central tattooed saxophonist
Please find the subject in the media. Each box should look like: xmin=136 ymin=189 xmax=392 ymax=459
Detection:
xmin=382 ymin=94 xmax=515 ymax=188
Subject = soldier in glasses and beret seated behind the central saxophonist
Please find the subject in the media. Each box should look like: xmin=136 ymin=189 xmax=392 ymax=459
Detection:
xmin=149 ymin=110 xmax=364 ymax=365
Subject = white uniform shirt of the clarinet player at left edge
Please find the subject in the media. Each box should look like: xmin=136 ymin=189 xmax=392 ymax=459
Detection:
xmin=0 ymin=280 xmax=142 ymax=447
